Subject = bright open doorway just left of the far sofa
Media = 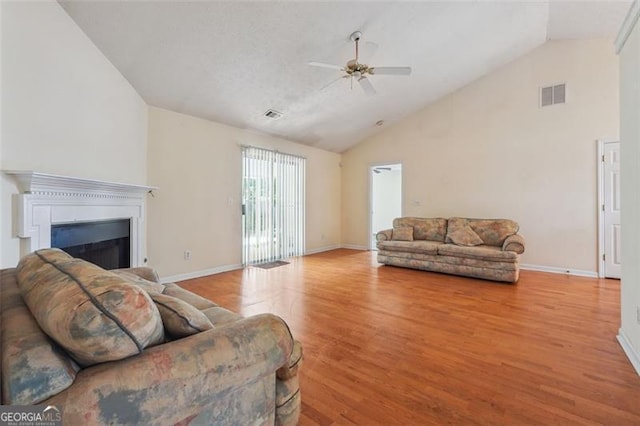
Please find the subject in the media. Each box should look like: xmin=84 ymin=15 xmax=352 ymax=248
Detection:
xmin=369 ymin=163 xmax=402 ymax=250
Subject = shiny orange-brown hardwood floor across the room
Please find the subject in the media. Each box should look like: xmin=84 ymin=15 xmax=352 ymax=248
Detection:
xmin=180 ymin=250 xmax=640 ymax=425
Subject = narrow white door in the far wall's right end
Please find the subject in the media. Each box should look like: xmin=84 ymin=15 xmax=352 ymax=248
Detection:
xmin=602 ymin=142 xmax=621 ymax=278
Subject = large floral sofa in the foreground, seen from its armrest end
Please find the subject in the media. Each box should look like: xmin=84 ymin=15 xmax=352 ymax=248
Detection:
xmin=0 ymin=249 xmax=302 ymax=425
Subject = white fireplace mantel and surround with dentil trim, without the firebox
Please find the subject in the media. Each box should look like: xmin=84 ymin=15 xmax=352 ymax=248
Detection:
xmin=4 ymin=170 xmax=156 ymax=266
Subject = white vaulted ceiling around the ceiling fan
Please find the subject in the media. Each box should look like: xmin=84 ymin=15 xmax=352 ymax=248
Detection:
xmin=60 ymin=0 xmax=631 ymax=152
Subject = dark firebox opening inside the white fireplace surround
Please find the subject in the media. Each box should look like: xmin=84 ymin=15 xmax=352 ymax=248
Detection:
xmin=51 ymin=219 xmax=131 ymax=269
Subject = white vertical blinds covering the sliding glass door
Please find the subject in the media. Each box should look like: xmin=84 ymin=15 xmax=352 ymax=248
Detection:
xmin=242 ymin=146 xmax=305 ymax=265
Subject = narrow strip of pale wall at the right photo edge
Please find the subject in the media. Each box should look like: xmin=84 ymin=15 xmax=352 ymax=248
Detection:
xmin=620 ymin=5 xmax=640 ymax=374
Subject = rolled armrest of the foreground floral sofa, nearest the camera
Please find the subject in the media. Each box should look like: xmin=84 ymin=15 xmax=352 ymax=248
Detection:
xmin=42 ymin=314 xmax=293 ymax=424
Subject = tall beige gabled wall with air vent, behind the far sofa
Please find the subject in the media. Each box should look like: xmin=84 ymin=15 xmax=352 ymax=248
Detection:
xmin=342 ymin=40 xmax=618 ymax=272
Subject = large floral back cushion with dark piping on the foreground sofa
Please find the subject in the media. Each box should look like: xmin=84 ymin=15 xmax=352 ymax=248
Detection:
xmin=17 ymin=249 xmax=164 ymax=366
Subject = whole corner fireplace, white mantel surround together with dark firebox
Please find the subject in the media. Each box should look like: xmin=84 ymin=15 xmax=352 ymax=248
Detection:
xmin=4 ymin=171 xmax=156 ymax=269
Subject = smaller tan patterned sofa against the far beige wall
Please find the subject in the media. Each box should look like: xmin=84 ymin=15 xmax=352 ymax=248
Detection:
xmin=376 ymin=217 xmax=524 ymax=283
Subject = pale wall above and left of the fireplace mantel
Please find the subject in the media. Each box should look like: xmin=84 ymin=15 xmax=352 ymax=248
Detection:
xmin=0 ymin=1 xmax=147 ymax=267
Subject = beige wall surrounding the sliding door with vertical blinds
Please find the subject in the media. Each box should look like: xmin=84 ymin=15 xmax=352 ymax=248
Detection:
xmin=147 ymin=107 xmax=341 ymax=278
